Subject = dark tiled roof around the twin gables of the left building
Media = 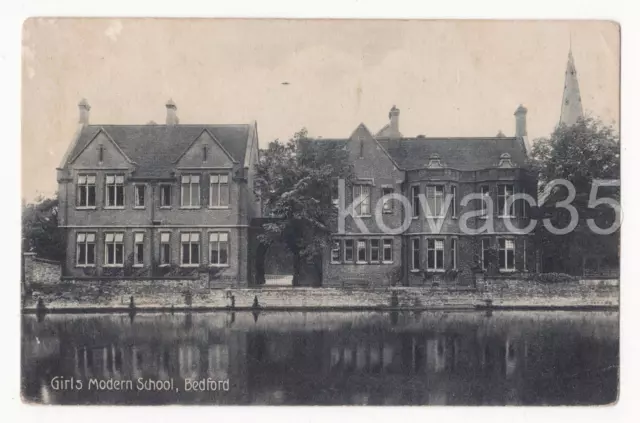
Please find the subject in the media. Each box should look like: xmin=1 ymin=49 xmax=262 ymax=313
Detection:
xmin=66 ymin=124 xmax=250 ymax=178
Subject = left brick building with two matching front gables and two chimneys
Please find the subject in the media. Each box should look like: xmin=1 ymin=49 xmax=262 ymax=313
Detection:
xmin=57 ymin=100 xmax=260 ymax=286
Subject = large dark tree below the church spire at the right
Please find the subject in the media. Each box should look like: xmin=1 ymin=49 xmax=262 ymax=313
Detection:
xmin=530 ymin=118 xmax=620 ymax=274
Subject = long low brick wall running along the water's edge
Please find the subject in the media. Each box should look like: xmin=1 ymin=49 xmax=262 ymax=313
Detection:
xmin=25 ymin=277 xmax=619 ymax=309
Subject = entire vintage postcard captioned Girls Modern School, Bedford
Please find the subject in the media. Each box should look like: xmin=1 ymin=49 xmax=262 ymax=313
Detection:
xmin=21 ymin=18 xmax=621 ymax=405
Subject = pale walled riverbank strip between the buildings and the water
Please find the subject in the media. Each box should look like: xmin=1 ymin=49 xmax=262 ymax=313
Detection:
xmin=23 ymin=281 xmax=619 ymax=313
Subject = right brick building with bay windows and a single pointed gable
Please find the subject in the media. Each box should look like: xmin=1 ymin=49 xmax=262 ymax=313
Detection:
xmin=317 ymin=106 xmax=537 ymax=286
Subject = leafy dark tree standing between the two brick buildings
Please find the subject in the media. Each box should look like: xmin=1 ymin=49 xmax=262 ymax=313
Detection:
xmin=255 ymin=129 xmax=353 ymax=286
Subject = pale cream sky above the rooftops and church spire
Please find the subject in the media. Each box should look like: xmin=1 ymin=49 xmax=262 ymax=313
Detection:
xmin=22 ymin=18 xmax=620 ymax=201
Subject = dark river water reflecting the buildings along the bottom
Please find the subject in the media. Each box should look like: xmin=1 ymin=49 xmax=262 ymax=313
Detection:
xmin=22 ymin=311 xmax=618 ymax=405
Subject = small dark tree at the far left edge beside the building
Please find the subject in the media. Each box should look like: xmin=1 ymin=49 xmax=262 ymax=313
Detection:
xmin=22 ymin=197 xmax=65 ymax=261
